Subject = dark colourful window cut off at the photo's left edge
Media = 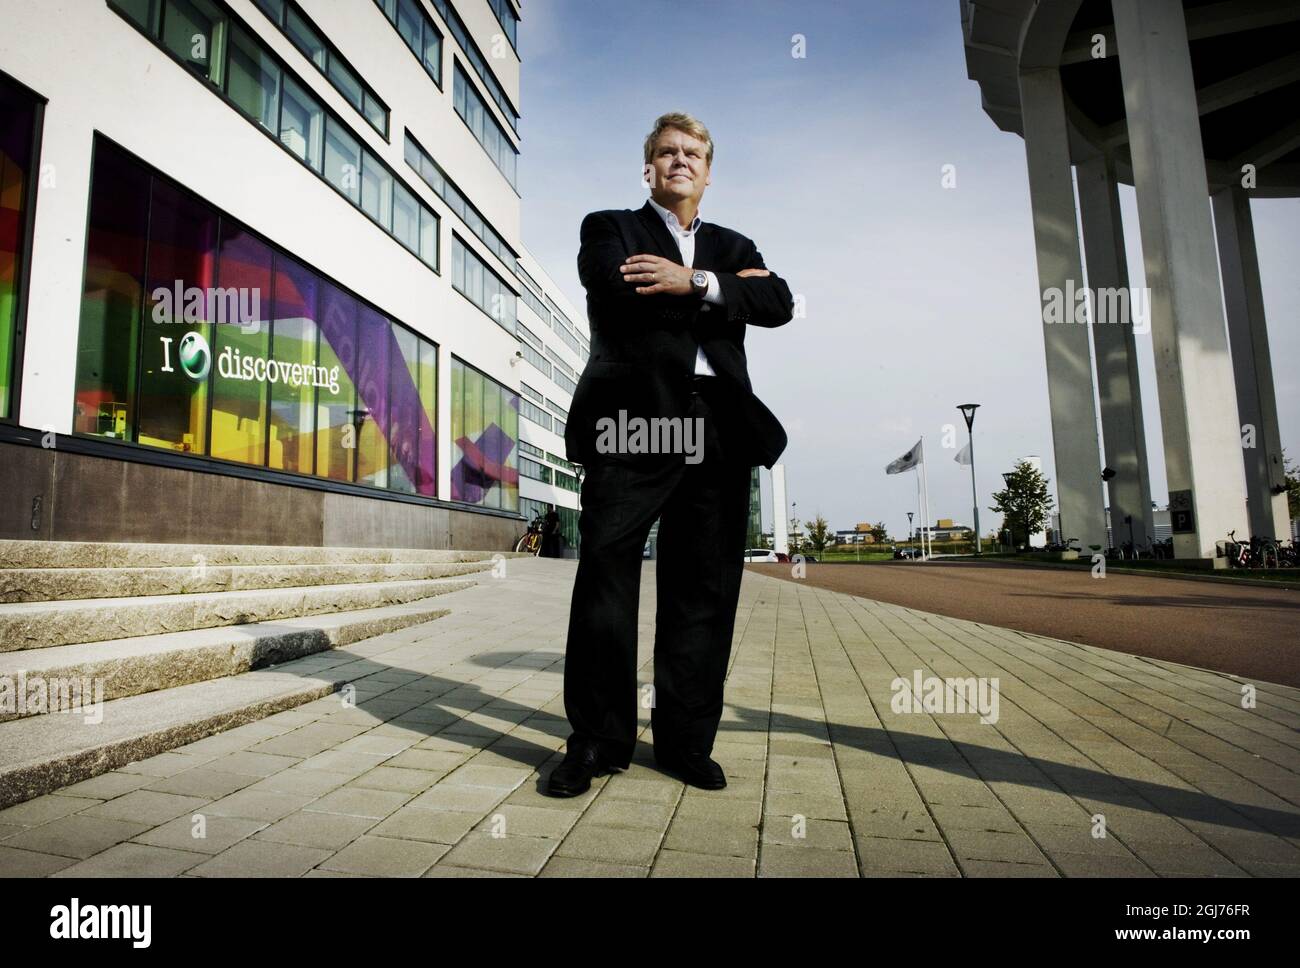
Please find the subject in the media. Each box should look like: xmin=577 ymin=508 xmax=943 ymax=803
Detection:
xmin=0 ymin=77 xmax=36 ymax=420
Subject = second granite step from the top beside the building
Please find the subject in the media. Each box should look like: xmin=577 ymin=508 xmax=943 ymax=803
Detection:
xmin=0 ymin=559 xmax=493 ymax=603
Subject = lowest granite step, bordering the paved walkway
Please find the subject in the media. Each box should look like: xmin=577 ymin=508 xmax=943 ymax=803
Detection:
xmin=0 ymin=648 xmax=374 ymax=808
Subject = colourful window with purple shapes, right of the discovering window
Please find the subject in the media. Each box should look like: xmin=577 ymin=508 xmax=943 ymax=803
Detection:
xmin=451 ymin=356 xmax=519 ymax=511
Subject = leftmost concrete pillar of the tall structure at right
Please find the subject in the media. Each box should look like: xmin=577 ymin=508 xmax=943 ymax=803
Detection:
xmin=1021 ymin=70 xmax=1106 ymax=551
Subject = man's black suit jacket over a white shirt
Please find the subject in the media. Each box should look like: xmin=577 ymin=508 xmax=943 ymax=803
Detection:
xmin=564 ymin=201 xmax=794 ymax=468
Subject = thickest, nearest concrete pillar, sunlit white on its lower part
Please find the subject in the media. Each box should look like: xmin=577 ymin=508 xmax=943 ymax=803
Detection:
xmin=1112 ymin=0 xmax=1248 ymax=557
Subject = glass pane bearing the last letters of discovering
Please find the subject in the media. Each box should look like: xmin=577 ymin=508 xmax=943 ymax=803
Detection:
xmin=316 ymin=283 xmax=358 ymax=481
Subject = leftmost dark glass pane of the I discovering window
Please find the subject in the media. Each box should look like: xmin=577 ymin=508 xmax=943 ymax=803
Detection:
xmin=73 ymin=139 xmax=150 ymax=440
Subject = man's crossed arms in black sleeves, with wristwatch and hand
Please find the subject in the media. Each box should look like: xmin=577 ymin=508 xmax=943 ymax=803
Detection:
xmin=577 ymin=212 xmax=794 ymax=326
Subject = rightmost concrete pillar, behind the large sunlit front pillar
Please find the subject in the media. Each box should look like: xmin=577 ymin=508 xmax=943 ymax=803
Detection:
xmin=1214 ymin=186 xmax=1291 ymax=541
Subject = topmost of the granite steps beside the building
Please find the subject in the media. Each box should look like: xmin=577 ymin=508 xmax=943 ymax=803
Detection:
xmin=0 ymin=540 xmax=524 ymax=569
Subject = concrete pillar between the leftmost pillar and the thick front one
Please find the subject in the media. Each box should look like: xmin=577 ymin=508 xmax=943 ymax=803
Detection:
xmin=1075 ymin=155 xmax=1156 ymax=548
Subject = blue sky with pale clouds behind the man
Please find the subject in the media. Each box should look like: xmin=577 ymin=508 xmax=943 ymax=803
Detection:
xmin=519 ymin=0 xmax=1300 ymax=535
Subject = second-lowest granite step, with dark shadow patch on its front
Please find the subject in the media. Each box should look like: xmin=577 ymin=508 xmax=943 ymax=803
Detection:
xmin=0 ymin=596 xmax=449 ymax=722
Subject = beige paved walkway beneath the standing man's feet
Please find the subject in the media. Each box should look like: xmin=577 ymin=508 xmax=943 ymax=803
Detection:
xmin=0 ymin=550 xmax=1300 ymax=877
